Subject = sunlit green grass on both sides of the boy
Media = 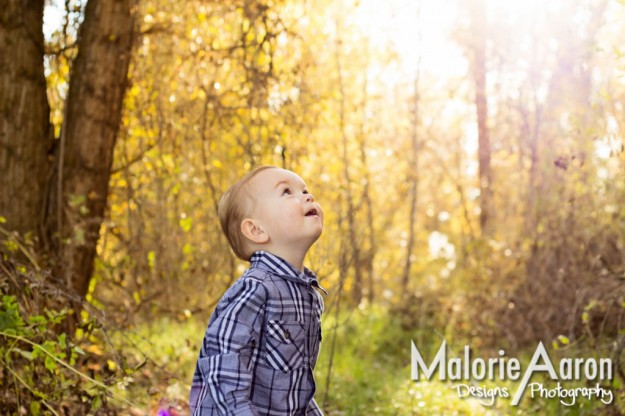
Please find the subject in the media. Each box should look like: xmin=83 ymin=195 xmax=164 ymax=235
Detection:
xmin=119 ymin=308 xmax=623 ymax=416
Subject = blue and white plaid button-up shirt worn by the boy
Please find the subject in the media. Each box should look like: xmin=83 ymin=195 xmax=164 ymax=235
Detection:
xmin=190 ymin=251 xmax=325 ymax=416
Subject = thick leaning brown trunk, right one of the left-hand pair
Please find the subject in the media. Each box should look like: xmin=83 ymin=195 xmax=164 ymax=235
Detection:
xmin=46 ymin=0 xmax=134 ymax=297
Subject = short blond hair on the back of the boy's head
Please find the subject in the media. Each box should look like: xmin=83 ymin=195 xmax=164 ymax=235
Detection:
xmin=217 ymin=166 xmax=276 ymax=261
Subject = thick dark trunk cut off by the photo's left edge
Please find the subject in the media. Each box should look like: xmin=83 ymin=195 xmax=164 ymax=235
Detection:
xmin=0 ymin=0 xmax=53 ymax=236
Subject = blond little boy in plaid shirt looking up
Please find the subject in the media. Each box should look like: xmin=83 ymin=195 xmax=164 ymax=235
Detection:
xmin=190 ymin=166 xmax=325 ymax=416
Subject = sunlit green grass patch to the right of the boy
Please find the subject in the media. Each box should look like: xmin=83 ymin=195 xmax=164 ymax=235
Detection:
xmin=316 ymin=308 xmax=622 ymax=416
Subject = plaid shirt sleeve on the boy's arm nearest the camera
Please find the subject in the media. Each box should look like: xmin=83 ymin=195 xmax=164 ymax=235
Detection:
xmin=190 ymin=279 xmax=266 ymax=416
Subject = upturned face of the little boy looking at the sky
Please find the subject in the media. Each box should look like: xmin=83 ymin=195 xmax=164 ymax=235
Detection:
xmin=249 ymin=168 xmax=323 ymax=253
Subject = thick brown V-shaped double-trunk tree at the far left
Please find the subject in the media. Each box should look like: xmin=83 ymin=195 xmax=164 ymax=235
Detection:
xmin=0 ymin=0 xmax=134 ymax=312
